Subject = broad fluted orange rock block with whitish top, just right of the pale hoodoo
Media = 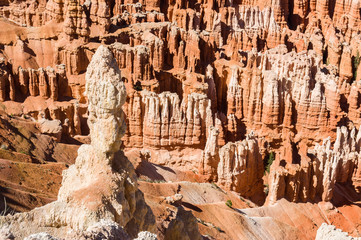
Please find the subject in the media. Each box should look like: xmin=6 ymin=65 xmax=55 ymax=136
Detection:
xmin=124 ymin=90 xmax=213 ymax=148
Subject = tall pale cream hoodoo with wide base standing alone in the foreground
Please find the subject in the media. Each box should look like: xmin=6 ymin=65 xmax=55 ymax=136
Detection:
xmin=3 ymin=46 xmax=155 ymax=238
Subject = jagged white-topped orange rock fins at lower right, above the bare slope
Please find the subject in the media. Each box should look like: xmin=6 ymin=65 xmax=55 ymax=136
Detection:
xmin=268 ymin=126 xmax=360 ymax=203
